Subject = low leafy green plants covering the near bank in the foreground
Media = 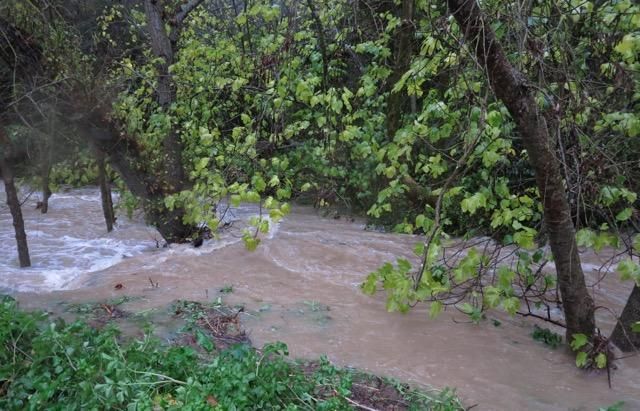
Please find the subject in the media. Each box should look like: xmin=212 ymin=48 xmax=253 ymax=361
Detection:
xmin=0 ymin=298 xmax=462 ymax=410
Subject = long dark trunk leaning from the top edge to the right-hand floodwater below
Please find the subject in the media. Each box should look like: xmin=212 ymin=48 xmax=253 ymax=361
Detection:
xmin=447 ymin=0 xmax=595 ymax=341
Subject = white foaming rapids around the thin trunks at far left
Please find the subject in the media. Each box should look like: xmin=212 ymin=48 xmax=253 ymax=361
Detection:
xmin=0 ymin=185 xmax=159 ymax=292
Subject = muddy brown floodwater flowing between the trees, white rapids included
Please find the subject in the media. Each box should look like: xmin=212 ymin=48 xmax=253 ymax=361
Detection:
xmin=0 ymin=188 xmax=640 ymax=410
